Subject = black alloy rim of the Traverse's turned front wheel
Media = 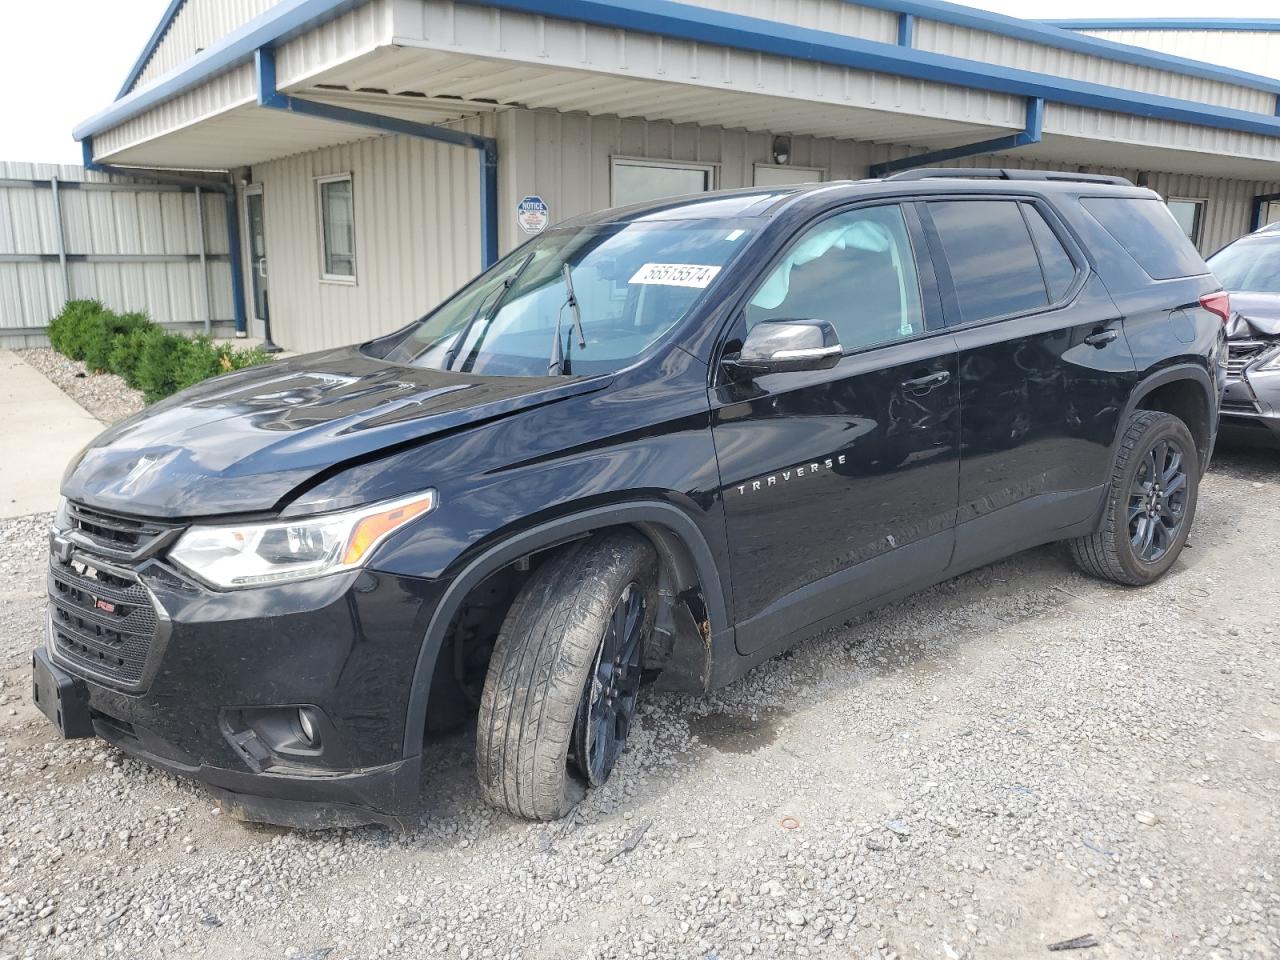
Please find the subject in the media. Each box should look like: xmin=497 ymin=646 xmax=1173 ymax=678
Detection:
xmin=573 ymin=582 xmax=648 ymax=787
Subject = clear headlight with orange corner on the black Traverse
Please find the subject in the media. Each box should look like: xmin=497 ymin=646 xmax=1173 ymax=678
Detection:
xmin=169 ymin=490 xmax=436 ymax=588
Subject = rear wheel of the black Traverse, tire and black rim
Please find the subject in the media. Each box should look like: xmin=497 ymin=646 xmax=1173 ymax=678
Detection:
xmin=1068 ymin=411 xmax=1201 ymax=586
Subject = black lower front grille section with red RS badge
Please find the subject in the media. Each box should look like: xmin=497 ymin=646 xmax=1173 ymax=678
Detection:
xmin=49 ymin=557 xmax=159 ymax=687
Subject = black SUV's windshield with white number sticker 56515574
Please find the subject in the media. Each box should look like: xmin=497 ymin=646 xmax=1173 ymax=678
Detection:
xmin=385 ymin=220 xmax=751 ymax=376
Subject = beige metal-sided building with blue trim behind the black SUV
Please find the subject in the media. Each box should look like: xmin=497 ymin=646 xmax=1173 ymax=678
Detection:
xmin=67 ymin=0 xmax=1280 ymax=351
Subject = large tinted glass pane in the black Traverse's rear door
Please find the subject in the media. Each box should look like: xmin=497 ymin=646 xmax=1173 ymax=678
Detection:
xmin=928 ymin=200 xmax=1048 ymax=323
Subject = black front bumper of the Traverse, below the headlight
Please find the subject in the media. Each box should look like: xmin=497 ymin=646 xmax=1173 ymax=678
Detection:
xmin=33 ymin=537 xmax=443 ymax=828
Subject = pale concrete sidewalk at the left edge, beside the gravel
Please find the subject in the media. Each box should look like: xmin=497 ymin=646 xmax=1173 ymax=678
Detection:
xmin=0 ymin=349 xmax=105 ymax=517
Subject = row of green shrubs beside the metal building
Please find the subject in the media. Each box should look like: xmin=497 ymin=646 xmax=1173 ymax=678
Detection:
xmin=49 ymin=300 xmax=271 ymax=403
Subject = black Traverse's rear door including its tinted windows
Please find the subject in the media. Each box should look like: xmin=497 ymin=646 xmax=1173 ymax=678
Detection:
xmin=922 ymin=195 xmax=1134 ymax=567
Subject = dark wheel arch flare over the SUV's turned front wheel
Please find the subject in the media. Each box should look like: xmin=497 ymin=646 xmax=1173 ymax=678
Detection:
xmin=403 ymin=500 xmax=736 ymax=756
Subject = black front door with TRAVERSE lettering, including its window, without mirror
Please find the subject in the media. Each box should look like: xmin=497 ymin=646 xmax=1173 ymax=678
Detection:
xmin=712 ymin=204 xmax=960 ymax=654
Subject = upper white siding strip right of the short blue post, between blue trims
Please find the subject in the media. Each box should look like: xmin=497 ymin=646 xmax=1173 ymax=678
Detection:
xmin=915 ymin=18 xmax=1276 ymax=115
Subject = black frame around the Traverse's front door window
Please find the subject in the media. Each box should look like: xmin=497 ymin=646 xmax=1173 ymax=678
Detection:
xmin=716 ymin=197 xmax=947 ymax=369
